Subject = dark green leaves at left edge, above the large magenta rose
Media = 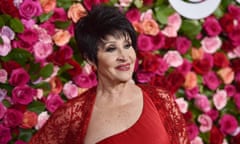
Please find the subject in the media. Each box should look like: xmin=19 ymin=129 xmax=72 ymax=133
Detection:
xmin=1 ymin=48 xmax=32 ymax=66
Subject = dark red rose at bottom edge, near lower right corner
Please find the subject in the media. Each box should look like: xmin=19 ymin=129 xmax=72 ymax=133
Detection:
xmin=209 ymin=126 xmax=224 ymax=144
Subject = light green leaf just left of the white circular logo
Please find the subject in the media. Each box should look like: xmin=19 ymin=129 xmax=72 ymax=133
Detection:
xmin=154 ymin=5 xmax=174 ymax=24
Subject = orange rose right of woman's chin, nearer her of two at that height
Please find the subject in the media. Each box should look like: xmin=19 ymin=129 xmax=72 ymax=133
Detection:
xmin=183 ymin=72 xmax=197 ymax=89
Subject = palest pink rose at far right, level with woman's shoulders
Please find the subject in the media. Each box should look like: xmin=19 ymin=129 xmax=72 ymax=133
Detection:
xmin=213 ymin=90 xmax=227 ymax=110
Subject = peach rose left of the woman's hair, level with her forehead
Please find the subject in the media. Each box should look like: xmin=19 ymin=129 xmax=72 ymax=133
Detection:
xmin=53 ymin=30 xmax=71 ymax=46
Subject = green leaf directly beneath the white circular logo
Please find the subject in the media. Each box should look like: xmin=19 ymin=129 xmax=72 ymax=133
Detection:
xmin=179 ymin=19 xmax=202 ymax=39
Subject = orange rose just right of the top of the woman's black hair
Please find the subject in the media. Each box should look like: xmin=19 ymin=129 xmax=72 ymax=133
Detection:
xmin=142 ymin=19 xmax=160 ymax=36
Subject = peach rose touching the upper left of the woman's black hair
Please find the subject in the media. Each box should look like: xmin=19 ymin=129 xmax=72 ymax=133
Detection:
xmin=68 ymin=3 xmax=87 ymax=23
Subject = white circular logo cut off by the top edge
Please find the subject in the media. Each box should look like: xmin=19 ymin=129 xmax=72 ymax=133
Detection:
xmin=169 ymin=0 xmax=221 ymax=19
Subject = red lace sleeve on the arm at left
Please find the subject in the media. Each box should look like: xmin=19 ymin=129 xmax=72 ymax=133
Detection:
xmin=29 ymin=105 xmax=72 ymax=144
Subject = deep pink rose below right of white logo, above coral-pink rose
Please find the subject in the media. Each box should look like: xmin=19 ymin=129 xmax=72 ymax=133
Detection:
xmin=203 ymin=16 xmax=222 ymax=36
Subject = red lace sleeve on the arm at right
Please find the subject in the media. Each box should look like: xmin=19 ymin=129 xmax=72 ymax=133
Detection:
xmin=157 ymin=89 xmax=189 ymax=144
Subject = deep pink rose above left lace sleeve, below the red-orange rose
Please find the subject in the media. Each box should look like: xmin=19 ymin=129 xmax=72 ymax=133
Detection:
xmin=46 ymin=94 xmax=64 ymax=113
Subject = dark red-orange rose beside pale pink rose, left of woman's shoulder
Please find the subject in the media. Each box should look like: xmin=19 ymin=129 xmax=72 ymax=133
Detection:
xmin=50 ymin=77 xmax=63 ymax=94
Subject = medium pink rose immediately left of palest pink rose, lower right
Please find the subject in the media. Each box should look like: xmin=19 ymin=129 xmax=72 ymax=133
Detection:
xmin=195 ymin=94 xmax=211 ymax=112
